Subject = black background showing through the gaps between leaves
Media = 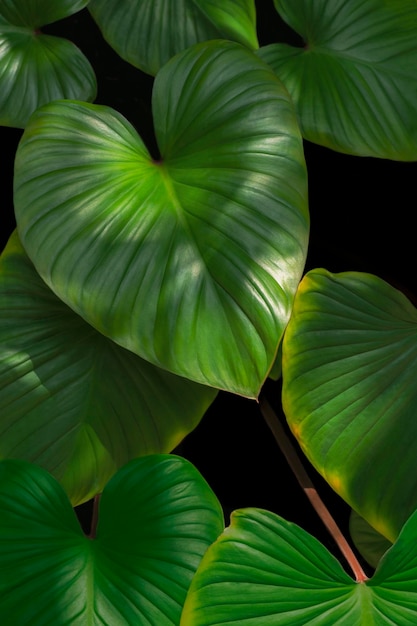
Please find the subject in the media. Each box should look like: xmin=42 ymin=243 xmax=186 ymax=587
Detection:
xmin=0 ymin=0 xmax=417 ymax=576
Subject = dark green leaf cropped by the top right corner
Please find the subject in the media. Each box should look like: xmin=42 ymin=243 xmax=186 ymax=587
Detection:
xmin=260 ymin=0 xmax=417 ymax=161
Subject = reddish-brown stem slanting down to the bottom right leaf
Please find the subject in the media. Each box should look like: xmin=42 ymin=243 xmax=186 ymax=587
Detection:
xmin=259 ymin=397 xmax=368 ymax=583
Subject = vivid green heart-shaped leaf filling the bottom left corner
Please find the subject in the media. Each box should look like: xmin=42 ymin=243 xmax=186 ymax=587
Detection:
xmin=0 ymin=455 xmax=224 ymax=626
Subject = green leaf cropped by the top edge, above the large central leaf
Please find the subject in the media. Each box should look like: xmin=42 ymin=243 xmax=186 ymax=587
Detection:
xmin=88 ymin=0 xmax=258 ymax=75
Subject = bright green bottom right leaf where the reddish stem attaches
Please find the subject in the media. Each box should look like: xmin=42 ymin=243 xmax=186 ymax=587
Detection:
xmin=181 ymin=509 xmax=417 ymax=626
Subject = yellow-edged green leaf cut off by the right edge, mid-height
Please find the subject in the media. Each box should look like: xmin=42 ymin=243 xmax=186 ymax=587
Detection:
xmin=282 ymin=270 xmax=417 ymax=541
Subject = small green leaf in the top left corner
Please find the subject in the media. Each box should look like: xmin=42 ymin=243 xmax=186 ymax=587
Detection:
xmin=0 ymin=0 xmax=96 ymax=128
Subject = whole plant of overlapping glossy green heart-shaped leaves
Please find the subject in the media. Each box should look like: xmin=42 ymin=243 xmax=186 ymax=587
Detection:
xmin=0 ymin=0 xmax=417 ymax=626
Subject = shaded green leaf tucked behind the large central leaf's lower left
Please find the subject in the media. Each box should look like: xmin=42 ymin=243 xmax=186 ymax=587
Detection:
xmin=0 ymin=234 xmax=216 ymax=505
